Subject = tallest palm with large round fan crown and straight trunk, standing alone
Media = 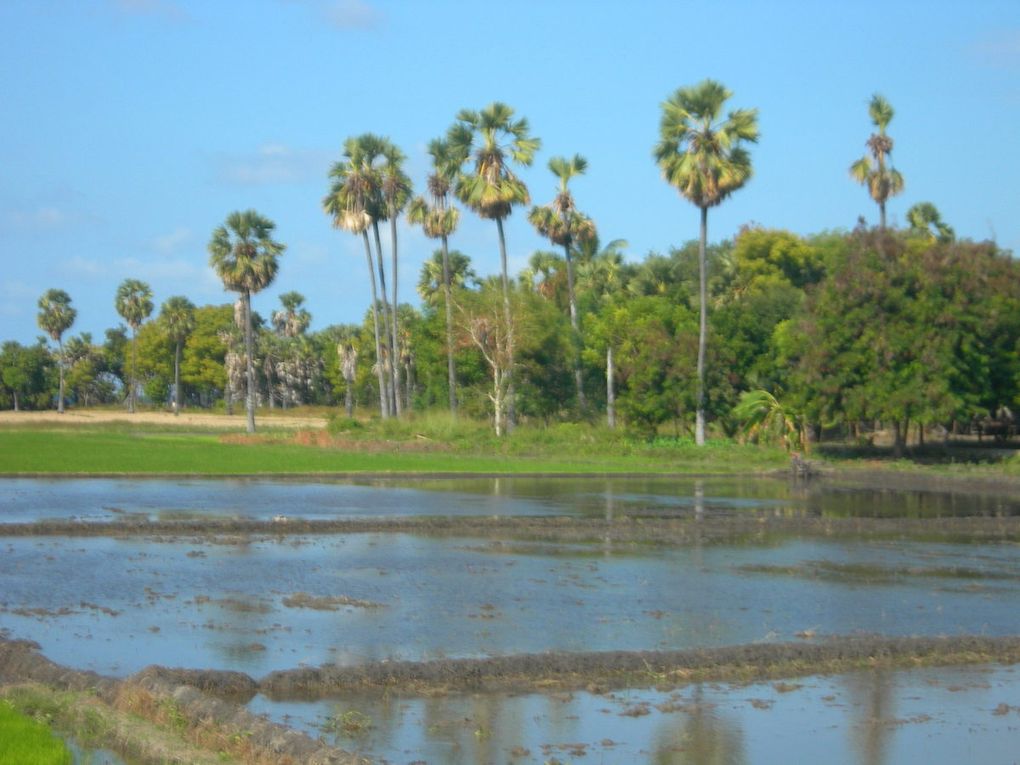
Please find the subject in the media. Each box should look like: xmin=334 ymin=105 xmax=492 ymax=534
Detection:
xmin=655 ymin=80 xmax=758 ymax=446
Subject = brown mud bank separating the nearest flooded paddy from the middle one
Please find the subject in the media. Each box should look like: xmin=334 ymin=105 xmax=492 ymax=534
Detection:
xmin=252 ymin=635 xmax=1020 ymax=700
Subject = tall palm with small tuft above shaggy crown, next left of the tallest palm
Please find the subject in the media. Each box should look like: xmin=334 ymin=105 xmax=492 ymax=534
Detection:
xmin=527 ymin=154 xmax=596 ymax=412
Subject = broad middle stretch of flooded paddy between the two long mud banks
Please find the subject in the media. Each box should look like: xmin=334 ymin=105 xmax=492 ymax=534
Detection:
xmin=0 ymin=533 xmax=1020 ymax=676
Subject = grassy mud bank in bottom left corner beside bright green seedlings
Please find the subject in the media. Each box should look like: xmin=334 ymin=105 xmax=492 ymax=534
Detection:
xmin=0 ymin=641 xmax=367 ymax=765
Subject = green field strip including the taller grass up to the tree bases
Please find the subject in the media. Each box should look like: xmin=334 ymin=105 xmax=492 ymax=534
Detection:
xmin=0 ymin=420 xmax=787 ymax=475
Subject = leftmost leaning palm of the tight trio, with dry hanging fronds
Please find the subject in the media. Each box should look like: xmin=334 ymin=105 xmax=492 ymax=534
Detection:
xmin=322 ymin=137 xmax=390 ymax=419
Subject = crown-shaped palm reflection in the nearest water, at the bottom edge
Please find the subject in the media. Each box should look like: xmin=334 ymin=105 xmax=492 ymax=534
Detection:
xmin=652 ymin=684 xmax=748 ymax=765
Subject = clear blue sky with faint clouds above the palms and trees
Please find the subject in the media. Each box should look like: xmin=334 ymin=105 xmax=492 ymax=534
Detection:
xmin=0 ymin=0 xmax=1020 ymax=343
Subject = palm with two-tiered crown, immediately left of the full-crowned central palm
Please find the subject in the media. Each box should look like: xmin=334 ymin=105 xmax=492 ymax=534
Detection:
xmin=407 ymin=139 xmax=466 ymax=412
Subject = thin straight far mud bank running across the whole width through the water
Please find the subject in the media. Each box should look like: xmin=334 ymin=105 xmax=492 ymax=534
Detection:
xmin=0 ymin=511 xmax=1020 ymax=546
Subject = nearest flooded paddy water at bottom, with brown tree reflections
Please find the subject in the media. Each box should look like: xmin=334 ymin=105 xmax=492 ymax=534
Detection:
xmin=249 ymin=667 xmax=1020 ymax=765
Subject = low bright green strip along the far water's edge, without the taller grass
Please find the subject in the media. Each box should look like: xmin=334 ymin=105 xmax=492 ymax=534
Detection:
xmin=0 ymin=428 xmax=785 ymax=475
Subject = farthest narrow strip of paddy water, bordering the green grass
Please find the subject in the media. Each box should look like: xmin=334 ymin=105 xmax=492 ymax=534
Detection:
xmin=0 ymin=477 xmax=1020 ymax=523
